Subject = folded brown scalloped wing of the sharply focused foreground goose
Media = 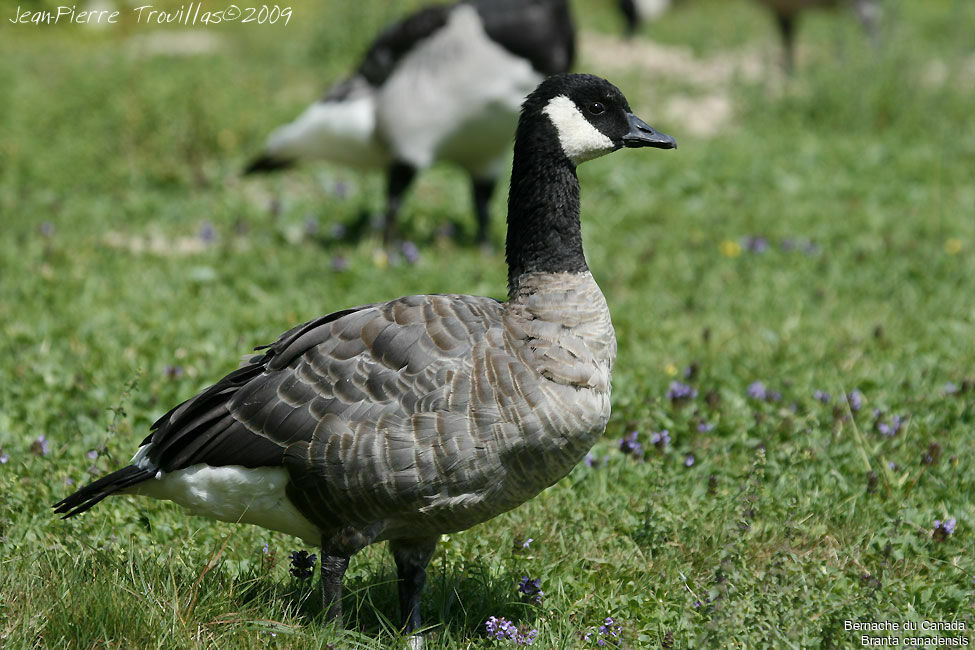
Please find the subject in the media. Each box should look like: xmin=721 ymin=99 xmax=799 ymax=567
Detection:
xmin=143 ymin=296 xmax=500 ymax=471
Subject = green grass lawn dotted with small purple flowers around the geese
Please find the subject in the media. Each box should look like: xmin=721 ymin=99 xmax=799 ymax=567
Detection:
xmin=0 ymin=0 xmax=975 ymax=648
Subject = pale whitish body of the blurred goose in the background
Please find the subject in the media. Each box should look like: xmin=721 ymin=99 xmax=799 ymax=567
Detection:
xmin=376 ymin=5 xmax=543 ymax=173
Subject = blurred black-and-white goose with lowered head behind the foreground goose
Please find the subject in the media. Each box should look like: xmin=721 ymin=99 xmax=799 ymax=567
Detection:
xmin=245 ymin=0 xmax=575 ymax=243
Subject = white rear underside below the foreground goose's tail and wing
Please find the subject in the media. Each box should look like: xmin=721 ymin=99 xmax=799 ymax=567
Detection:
xmin=131 ymin=464 xmax=321 ymax=545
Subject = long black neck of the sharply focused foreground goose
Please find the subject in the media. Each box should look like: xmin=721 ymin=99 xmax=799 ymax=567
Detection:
xmin=505 ymin=117 xmax=589 ymax=296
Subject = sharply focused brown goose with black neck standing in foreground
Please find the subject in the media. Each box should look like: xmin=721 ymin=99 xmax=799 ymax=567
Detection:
xmin=54 ymin=74 xmax=676 ymax=632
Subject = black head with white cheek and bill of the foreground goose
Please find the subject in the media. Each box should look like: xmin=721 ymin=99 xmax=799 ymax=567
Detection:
xmin=522 ymin=74 xmax=677 ymax=165
